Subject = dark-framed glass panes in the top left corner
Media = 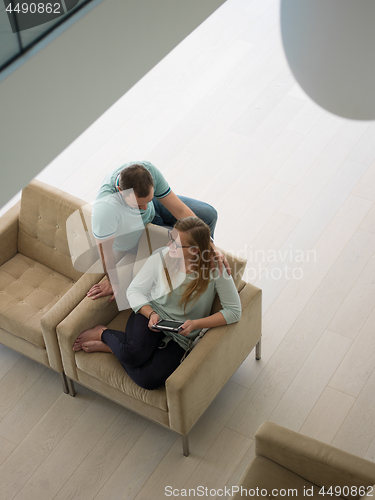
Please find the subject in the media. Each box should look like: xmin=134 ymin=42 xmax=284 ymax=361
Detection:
xmin=0 ymin=0 xmax=93 ymax=71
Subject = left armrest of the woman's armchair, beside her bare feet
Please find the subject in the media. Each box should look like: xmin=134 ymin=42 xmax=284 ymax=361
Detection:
xmin=56 ymin=286 xmax=119 ymax=380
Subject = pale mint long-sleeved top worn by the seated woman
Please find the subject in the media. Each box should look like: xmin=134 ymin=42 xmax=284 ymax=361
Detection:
xmin=126 ymin=248 xmax=241 ymax=349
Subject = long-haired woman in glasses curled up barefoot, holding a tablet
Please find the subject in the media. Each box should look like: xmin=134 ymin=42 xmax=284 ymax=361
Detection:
xmin=73 ymin=217 xmax=241 ymax=389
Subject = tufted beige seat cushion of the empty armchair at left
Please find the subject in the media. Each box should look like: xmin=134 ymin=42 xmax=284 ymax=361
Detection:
xmin=0 ymin=253 xmax=74 ymax=348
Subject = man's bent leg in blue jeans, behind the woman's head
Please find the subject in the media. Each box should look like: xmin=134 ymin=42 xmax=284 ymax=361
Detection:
xmin=152 ymin=196 xmax=217 ymax=237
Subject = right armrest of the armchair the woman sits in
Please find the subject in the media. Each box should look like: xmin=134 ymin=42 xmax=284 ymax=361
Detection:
xmin=165 ymin=283 xmax=262 ymax=434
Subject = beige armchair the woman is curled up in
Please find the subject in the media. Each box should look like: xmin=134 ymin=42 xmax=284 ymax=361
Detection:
xmin=57 ymin=225 xmax=262 ymax=455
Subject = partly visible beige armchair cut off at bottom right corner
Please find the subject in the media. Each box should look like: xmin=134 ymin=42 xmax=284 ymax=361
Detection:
xmin=232 ymin=422 xmax=375 ymax=500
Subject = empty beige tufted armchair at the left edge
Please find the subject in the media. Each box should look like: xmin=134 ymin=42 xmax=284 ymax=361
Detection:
xmin=0 ymin=180 xmax=103 ymax=392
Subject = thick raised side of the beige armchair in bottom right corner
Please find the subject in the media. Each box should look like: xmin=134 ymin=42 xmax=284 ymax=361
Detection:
xmin=255 ymin=422 xmax=375 ymax=492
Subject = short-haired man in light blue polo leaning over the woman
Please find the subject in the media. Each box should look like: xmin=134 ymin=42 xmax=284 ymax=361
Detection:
xmin=87 ymin=161 xmax=230 ymax=302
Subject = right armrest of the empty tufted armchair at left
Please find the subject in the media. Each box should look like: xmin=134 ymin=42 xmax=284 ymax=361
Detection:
xmin=40 ymin=273 xmax=108 ymax=372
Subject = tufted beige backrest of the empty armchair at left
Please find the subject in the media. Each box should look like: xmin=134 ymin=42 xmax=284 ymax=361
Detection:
xmin=18 ymin=180 xmax=86 ymax=280
